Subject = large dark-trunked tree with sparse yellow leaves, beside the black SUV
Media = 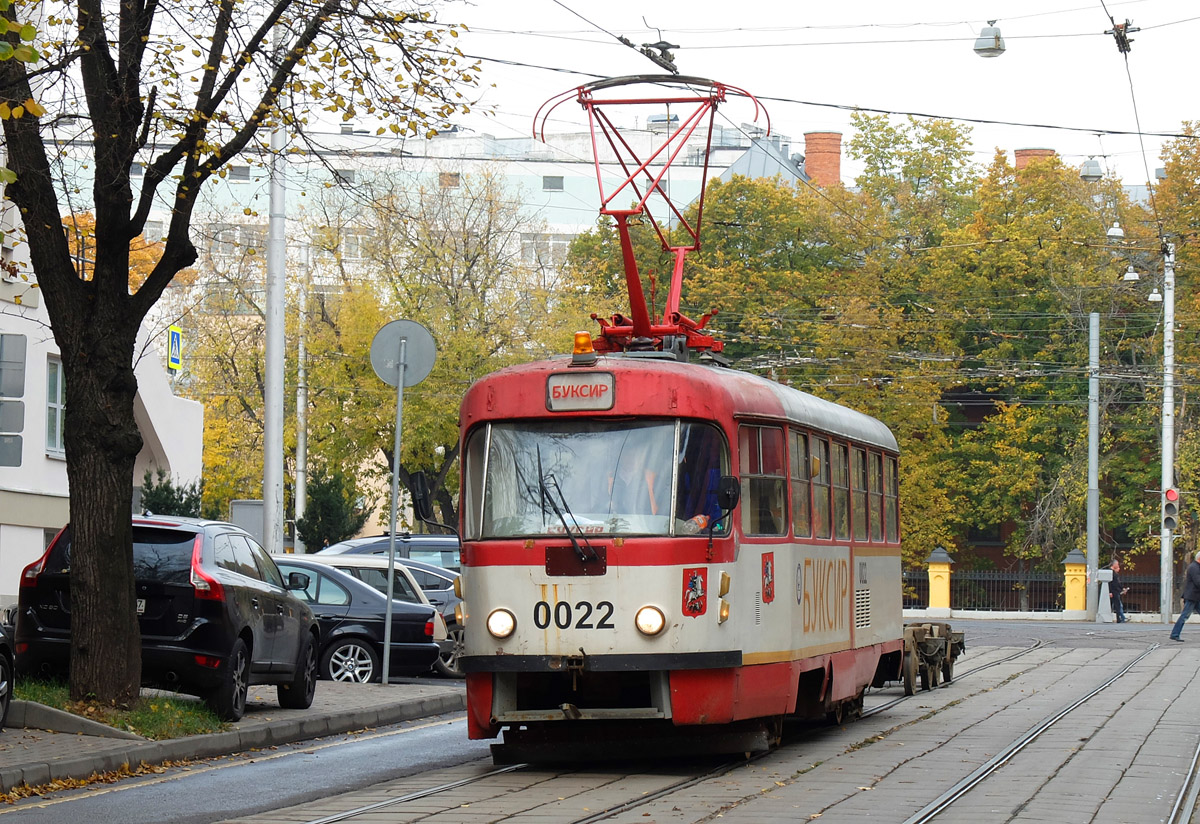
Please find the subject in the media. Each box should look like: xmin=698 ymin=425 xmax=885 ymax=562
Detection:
xmin=0 ymin=0 xmax=475 ymax=703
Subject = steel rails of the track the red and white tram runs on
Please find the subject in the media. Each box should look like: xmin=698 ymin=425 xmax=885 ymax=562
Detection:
xmin=283 ymin=639 xmax=1045 ymax=824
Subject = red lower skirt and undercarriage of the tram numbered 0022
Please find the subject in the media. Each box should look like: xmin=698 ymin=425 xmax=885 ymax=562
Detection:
xmin=467 ymin=644 xmax=902 ymax=764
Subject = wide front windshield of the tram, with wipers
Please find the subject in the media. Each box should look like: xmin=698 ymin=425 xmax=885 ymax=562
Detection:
xmin=463 ymin=419 xmax=730 ymax=539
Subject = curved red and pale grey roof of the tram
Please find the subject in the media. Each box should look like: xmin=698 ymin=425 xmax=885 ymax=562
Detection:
xmin=463 ymin=355 xmax=899 ymax=452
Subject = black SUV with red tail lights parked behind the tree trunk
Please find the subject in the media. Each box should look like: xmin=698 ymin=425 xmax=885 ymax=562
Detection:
xmin=13 ymin=516 xmax=318 ymax=721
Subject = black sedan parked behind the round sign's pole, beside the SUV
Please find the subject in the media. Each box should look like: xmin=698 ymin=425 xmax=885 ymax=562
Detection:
xmin=275 ymin=555 xmax=444 ymax=684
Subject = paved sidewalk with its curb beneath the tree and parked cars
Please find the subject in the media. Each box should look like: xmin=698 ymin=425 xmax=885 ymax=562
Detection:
xmin=0 ymin=680 xmax=467 ymax=793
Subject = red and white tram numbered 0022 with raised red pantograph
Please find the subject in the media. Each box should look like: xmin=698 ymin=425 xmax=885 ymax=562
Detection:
xmin=451 ymin=78 xmax=904 ymax=760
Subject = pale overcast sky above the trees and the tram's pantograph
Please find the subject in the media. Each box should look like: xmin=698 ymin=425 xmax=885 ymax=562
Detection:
xmin=439 ymin=0 xmax=1200 ymax=184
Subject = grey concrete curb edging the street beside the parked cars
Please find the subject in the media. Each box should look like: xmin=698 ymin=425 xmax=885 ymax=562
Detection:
xmin=0 ymin=691 xmax=467 ymax=793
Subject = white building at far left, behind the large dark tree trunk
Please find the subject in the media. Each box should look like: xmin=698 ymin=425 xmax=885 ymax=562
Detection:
xmin=0 ymin=244 xmax=204 ymax=606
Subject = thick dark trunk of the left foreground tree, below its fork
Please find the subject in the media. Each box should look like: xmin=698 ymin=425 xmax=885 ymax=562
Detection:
xmin=55 ymin=319 xmax=142 ymax=705
